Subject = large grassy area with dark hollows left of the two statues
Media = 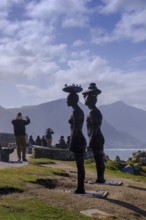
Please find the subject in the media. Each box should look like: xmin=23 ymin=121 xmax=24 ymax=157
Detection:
xmin=0 ymin=159 xmax=91 ymax=220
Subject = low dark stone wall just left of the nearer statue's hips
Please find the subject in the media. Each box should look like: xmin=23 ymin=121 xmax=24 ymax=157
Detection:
xmin=32 ymin=145 xmax=74 ymax=161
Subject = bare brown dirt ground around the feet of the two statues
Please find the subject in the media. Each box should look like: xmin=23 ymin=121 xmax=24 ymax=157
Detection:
xmin=28 ymin=163 xmax=146 ymax=220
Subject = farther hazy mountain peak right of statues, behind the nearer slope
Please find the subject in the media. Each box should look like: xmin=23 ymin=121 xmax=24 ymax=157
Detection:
xmin=100 ymin=102 xmax=146 ymax=143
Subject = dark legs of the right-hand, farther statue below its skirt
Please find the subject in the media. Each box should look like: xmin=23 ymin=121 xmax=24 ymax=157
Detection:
xmin=92 ymin=149 xmax=105 ymax=183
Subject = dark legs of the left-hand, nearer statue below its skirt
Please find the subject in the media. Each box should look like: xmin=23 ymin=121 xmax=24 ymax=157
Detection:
xmin=74 ymin=152 xmax=85 ymax=191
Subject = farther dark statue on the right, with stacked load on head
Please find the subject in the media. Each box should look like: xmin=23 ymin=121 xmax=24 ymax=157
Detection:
xmin=82 ymin=83 xmax=105 ymax=183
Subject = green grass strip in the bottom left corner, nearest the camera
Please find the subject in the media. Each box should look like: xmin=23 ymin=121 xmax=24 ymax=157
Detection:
xmin=0 ymin=198 xmax=91 ymax=220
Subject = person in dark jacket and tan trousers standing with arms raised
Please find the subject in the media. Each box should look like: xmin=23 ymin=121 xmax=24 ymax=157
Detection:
xmin=12 ymin=112 xmax=30 ymax=162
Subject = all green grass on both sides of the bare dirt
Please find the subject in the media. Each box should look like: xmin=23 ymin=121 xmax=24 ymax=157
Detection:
xmin=0 ymin=159 xmax=146 ymax=220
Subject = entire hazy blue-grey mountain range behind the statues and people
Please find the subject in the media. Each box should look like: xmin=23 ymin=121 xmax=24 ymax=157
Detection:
xmin=0 ymin=99 xmax=146 ymax=149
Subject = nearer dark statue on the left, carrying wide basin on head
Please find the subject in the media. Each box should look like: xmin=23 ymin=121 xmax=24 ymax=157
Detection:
xmin=63 ymin=84 xmax=86 ymax=194
